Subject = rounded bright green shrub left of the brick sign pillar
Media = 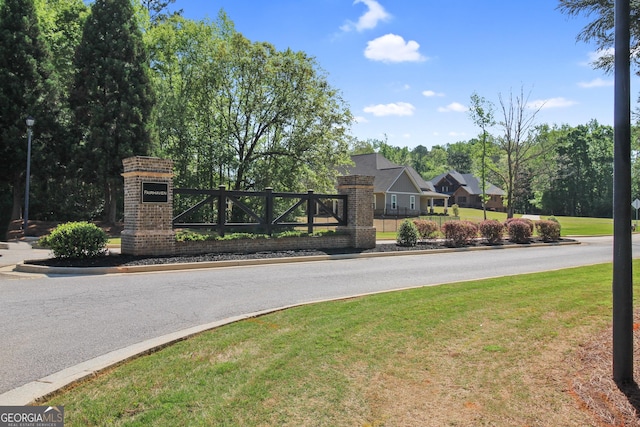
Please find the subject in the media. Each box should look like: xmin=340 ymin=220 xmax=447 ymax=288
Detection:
xmin=39 ymin=221 xmax=108 ymax=258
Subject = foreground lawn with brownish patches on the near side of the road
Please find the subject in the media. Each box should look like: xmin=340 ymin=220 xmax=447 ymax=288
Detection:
xmin=40 ymin=263 xmax=640 ymax=427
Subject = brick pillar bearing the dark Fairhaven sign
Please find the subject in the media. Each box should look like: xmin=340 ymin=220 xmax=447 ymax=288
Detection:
xmin=121 ymin=156 xmax=175 ymax=255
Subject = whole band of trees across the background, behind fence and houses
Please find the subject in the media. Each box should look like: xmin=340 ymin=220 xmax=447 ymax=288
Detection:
xmin=0 ymin=0 xmax=640 ymax=241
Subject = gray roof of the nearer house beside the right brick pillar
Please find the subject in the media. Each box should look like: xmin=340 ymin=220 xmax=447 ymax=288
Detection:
xmin=345 ymin=153 xmax=438 ymax=194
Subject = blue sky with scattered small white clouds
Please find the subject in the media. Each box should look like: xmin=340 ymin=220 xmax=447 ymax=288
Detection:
xmin=168 ymin=0 xmax=640 ymax=148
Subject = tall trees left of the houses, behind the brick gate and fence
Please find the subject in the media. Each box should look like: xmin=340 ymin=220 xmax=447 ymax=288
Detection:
xmin=0 ymin=0 xmax=352 ymax=236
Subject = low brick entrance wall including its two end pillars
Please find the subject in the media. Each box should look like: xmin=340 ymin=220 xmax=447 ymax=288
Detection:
xmin=121 ymin=156 xmax=376 ymax=255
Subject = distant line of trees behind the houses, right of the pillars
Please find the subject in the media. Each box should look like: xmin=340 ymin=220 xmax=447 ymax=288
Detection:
xmin=353 ymin=120 xmax=640 ymax=221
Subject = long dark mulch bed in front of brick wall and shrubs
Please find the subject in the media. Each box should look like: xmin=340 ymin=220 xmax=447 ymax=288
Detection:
xmin=26 ymin=239 xmax=572 ymax=267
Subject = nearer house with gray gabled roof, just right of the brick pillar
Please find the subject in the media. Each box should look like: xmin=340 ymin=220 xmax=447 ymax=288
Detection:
xmin=342 ymin=153 xmax=449 ymax=216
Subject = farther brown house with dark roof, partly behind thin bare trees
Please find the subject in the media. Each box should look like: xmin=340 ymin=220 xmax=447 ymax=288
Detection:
xmin=431 ymin=170 xmax=505 ymax=212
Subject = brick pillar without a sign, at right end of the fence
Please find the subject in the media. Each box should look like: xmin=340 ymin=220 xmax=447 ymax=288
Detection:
xmin=338 ymin=175 xmax=376 ymax=249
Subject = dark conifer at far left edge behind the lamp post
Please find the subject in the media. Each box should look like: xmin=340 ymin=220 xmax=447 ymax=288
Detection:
xmin=0 ymin=0 xmax=60 ymax=227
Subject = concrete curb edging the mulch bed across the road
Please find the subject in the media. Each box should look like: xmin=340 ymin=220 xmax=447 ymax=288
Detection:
xmin=14 ymin=241 xmax=580 ymax=275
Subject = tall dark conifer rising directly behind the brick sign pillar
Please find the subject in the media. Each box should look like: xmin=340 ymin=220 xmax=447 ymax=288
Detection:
xmin=70 ymin=0 xmax=153 ymax=223
